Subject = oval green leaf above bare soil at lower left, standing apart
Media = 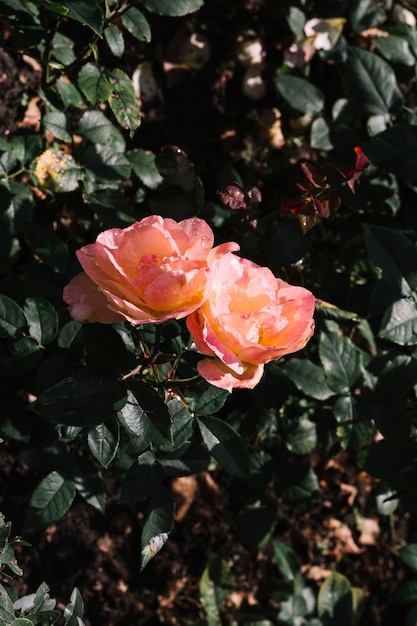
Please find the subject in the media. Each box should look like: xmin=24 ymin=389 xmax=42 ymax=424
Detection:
xmin=25 ymin=471 xmax=76 ymax=533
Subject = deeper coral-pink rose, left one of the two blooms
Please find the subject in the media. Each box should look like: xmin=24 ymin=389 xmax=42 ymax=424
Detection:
xmin=63 ymin=215 xmax=239 ymax=324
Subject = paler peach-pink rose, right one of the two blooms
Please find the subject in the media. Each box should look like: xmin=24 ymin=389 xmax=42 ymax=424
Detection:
xmin=187 ymin=253 xmax=314 ymax=391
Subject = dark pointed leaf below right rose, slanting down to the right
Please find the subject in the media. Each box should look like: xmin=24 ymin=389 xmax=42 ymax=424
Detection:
xmin=197 ymin=415 xmax=249 ymax=478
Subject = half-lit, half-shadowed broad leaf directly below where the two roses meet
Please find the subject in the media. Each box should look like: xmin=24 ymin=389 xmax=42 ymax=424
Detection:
xmin=118 ymin=382 xmax=173 ymax=445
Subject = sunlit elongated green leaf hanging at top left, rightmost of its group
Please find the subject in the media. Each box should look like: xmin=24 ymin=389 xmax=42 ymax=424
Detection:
xmin=108 ymin=68 xmax=141 ymax=137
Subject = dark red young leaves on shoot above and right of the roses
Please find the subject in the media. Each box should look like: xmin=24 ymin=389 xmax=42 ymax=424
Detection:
xmin=281 ymin=146 xmax=370 ymax=229
